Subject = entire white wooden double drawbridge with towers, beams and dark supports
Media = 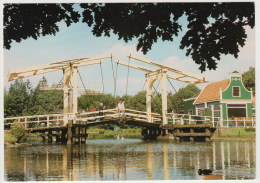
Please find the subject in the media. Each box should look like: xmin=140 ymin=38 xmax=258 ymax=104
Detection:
xmin=5 ymin=54 xmax=216 ymax=144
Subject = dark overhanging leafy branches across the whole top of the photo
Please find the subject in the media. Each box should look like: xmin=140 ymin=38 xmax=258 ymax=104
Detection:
xmin=4 ymin=2 xmax=255 ymax=71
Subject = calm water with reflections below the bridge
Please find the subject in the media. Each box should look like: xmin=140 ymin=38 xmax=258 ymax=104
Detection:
xmin=4 ymin=139 xmax=256 ymax=181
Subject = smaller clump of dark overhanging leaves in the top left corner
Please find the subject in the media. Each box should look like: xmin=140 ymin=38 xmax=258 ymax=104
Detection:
xmin=4 ymin=4 xmax=80 ymax=49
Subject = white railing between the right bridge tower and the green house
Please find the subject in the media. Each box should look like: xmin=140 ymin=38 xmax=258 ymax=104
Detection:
xmin=166 ymin=113 xmax=220 ymax=127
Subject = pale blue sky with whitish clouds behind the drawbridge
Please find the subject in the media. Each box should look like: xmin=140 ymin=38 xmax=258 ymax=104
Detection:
xmin=3 ymin=3 xmax=256 ymax=96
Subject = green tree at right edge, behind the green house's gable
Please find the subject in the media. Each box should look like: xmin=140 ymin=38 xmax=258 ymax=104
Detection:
xmin=242 ymin=67 xmax=255 ymax=95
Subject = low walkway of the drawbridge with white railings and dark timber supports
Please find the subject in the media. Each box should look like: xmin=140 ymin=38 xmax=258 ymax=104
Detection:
xmin=5 ymin=109 xmax=219 ymax=142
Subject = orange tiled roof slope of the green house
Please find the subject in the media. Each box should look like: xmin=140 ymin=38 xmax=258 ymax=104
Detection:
xmin=194 ymin=79 xmax=230 ymax=104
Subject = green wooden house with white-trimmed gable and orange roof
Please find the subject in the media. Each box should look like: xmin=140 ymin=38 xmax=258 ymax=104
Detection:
xmin=184 ymin=71 xmax=254 ymax=126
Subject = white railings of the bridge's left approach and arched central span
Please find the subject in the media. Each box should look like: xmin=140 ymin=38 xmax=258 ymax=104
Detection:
xmin=4 ymin=109 xmax=161 ymax=132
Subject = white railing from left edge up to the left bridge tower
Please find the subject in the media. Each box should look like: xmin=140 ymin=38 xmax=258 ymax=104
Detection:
xmin=4 ymin=114 xmax=67 ymax=128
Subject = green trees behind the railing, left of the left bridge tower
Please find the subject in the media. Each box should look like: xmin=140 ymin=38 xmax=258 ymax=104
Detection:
xmin=4 ymin=77 xmax=63 ymax=117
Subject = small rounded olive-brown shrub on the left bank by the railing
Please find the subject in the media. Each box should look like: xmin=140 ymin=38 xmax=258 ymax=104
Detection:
xmin=11 ymin=121 xmax=28 ymax=143
